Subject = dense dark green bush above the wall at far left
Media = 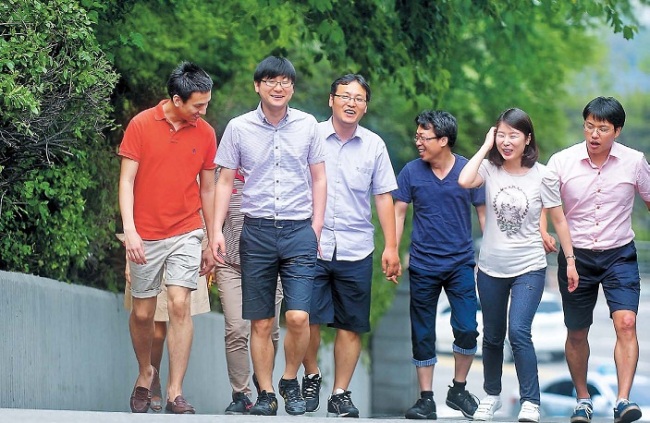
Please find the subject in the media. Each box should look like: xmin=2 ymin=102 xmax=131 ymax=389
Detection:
xmin=0 ymin=0 xmax=117 ymax=280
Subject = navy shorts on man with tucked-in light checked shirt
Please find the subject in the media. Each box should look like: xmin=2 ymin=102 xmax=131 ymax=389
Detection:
xmin=239 ymin=217 xmax=317 ymax=320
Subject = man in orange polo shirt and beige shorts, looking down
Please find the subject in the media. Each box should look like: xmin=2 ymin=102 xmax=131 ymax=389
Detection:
xmin=119 ymin=62 xmax=217 ymax=414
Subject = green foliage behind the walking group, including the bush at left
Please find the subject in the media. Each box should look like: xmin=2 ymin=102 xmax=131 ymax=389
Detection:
xmin=0 ymin=0 xmax=650 ymax=322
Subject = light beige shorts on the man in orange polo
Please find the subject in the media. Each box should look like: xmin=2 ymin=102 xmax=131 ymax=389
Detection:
xmin=129 ymin=229 xmax=203 ymax=298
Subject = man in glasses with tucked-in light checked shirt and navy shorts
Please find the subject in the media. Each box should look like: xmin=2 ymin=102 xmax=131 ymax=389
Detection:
xmin=213 ymin=56 xmax=327 ymax=415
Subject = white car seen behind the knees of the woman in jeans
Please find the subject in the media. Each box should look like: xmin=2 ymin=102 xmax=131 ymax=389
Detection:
xmin=436 ymin=292 xmax=566 ymax=361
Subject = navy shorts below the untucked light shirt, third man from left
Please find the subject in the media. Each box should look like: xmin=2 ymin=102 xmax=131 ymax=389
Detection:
xmin=309 ymin=251 xmax=372 ymax=333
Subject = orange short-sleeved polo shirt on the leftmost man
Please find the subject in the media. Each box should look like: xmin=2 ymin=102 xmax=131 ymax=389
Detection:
xmin=119 ymin=100 xmax=217 ymax=240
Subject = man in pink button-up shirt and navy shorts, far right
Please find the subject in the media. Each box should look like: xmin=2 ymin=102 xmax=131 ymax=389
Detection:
xmin=542 ymin=97 xmax=650 ymax=423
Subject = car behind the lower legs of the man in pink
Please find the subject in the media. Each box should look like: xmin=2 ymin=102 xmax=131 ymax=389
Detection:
xmin=511 ymin=371 xmax=650 ymax=421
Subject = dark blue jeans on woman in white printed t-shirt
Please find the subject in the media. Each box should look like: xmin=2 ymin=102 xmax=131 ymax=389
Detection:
xmin=476 ymin=268 xmax=546 ymax=404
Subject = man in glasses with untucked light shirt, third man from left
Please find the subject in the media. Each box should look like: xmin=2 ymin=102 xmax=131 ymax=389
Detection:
xmin=302 ymin=74 xmax=401 ymax=417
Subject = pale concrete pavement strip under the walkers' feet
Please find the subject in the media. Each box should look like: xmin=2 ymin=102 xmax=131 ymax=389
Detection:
xmin=0 ymin=408 xmax=576 ymax=423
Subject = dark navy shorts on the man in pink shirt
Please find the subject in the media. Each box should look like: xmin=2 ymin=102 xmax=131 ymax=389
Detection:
xmin=557 ymin=241 xmax=641 ymax=330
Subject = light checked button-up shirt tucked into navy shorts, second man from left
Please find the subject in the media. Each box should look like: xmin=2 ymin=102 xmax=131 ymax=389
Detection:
xmin=215 ymin=103 xmax=325 ymax=220
